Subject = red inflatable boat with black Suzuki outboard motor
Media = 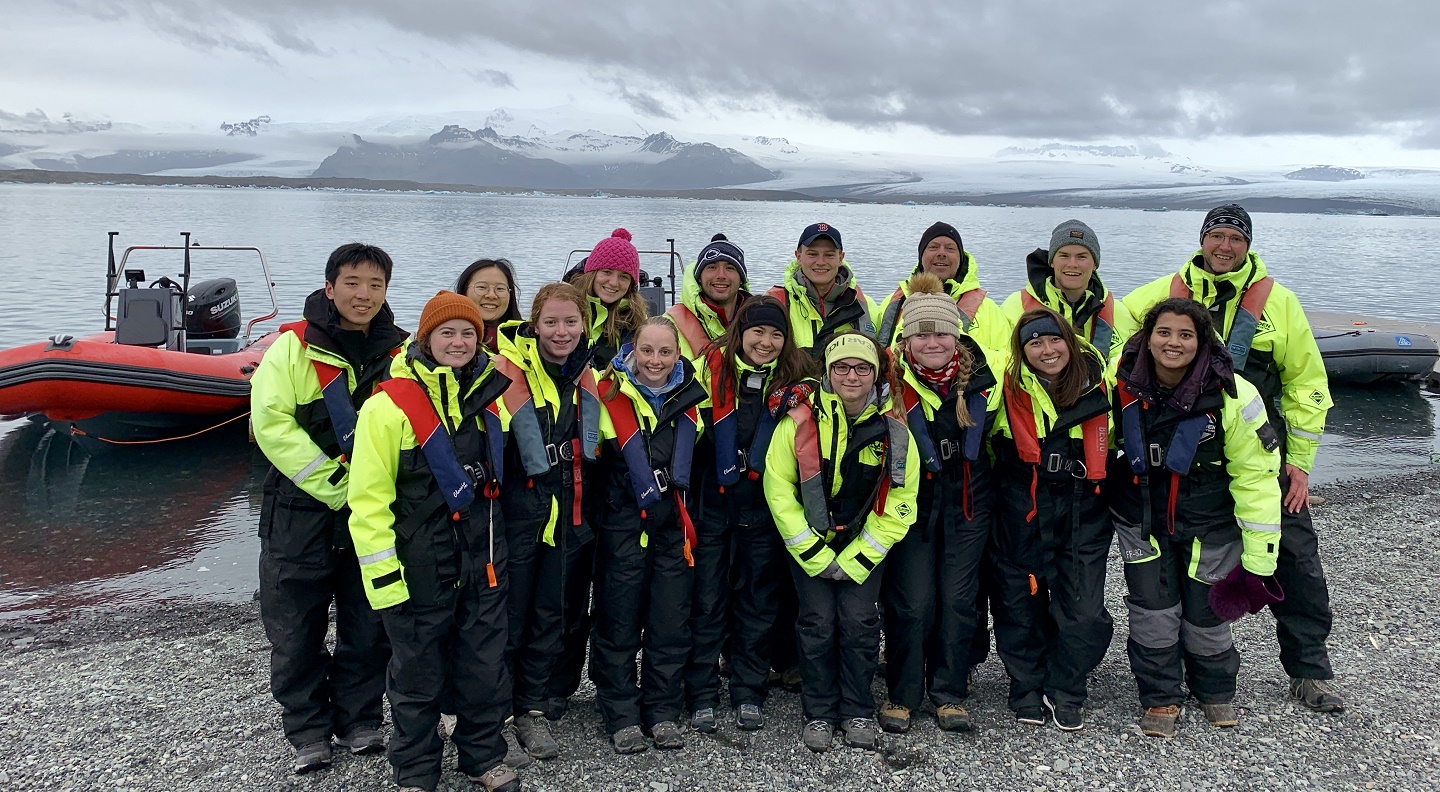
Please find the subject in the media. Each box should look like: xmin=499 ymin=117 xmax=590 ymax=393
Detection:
xmin=0 ymin=233 xmax=279 ymax=442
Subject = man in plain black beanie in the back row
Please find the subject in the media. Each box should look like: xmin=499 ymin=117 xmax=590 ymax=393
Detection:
xmin=874 ymin=222 xmax=1009 ymax=351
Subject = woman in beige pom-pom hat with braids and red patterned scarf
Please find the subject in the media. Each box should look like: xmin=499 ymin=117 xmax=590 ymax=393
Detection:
xmin=878 ymin=272 xmax=999 ymax=733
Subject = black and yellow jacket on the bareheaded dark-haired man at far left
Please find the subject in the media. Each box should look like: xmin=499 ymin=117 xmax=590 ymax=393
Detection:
xmin=251 ymin=289 xmax=406 ymax=511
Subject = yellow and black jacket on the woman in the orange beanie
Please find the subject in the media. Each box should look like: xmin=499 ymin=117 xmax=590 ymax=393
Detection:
xmin=348 ymin=348 xmax=510 ymax=611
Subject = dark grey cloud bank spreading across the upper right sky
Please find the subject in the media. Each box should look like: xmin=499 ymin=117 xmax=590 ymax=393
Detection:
xmin=81 ymin=0 xmax=1440 ymax=141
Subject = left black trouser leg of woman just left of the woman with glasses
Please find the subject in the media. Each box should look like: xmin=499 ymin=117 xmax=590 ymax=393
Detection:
xmin=684 ymin=514 xmax=731 ymax=711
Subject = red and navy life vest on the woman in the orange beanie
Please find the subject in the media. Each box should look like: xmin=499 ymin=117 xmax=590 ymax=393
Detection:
xmin=380 ymin=379 xmax=504 ymax=588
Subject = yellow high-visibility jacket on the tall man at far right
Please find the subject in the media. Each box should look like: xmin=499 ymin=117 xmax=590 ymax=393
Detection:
xmin=1123 ymin=251 xmax=1335 ymax=472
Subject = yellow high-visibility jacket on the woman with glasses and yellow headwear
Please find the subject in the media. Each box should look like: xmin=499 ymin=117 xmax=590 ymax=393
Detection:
xmin=763 ymin=390 xmax=920 ymax=583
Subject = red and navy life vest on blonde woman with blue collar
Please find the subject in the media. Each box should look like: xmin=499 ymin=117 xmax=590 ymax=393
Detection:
xmin=599 ymin=380 xmax=700 ymax=566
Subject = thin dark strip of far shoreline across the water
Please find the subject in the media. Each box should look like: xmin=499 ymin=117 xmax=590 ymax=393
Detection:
xmin=0 ymin=168 xmax=1440 ymax=217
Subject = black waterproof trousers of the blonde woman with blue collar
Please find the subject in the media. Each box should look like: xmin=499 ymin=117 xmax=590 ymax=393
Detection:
xmin=590 ymin=518 xmax=694 ymax=734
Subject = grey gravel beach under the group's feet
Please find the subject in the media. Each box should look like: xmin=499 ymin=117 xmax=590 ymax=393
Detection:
xmin=0 ymin=469 xmax=1440 ymax=792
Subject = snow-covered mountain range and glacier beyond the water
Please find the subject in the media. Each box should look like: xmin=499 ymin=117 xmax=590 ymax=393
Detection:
xmin=0 ymin=107 xmax=1440 ymax=213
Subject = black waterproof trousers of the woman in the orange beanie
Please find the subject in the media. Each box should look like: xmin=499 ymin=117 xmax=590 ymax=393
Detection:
xmin=382 ymin=578 xmax=511 ymax=789
